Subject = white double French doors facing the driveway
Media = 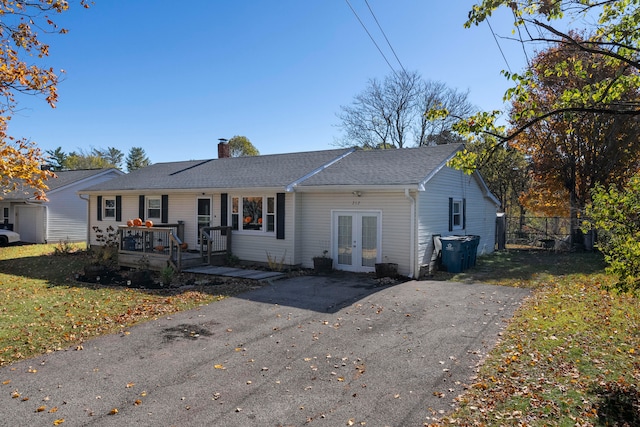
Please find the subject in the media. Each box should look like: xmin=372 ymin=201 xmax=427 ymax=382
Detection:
xmin=333 ymin=211 xmax=382 ymax=272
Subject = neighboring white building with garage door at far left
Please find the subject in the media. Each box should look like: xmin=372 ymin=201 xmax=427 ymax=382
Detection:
xmin=0 ymin=168 xmax=124 ymax=243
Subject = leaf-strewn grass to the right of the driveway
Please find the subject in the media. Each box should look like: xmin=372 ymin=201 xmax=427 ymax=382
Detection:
xmin=432 ymin=251 xmax=640 ymax=426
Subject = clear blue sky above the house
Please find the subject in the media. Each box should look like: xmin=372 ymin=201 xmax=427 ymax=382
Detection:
xmin=9 ymin=0 xmax=525 ymax=163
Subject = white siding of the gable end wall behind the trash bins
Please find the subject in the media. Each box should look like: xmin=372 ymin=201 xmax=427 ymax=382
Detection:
xmin=418 ymin=167 xmax=497 ymax=265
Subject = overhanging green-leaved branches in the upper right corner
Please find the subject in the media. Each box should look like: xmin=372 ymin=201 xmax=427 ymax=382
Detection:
xmin=459 ymin=0 xmax=640 ymax=144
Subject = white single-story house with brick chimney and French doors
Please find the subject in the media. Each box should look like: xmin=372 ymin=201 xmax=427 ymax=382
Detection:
xmin=80 ymin=143 xmax=499 ymax=277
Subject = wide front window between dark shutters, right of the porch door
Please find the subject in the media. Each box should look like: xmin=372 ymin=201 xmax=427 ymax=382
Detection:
xmin=231 ymin=196 xmax=276 ymax=233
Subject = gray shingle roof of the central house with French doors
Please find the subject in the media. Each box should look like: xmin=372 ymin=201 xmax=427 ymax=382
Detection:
xmin=83 ymin=144 xmax=462 ymax=192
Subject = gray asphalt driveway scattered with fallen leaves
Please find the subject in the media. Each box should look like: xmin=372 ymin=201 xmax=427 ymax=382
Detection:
xmin=0 ymin=275 xmax=528 ymax=427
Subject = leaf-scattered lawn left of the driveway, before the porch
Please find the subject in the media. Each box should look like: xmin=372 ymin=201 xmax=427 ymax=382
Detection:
xmin=0 ymin=245 xmax=258 ymax=366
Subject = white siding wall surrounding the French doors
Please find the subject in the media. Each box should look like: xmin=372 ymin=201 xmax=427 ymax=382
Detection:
xmin=297 ymin=191 xmax=411 ymax=275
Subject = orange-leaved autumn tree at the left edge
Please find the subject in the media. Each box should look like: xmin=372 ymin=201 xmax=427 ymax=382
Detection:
xmin=0 ymin=0 xmax=89 ymax=199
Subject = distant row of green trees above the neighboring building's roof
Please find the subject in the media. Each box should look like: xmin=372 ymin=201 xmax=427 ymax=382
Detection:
xmin=46 ymin=147 xmax=151 ymax=172
